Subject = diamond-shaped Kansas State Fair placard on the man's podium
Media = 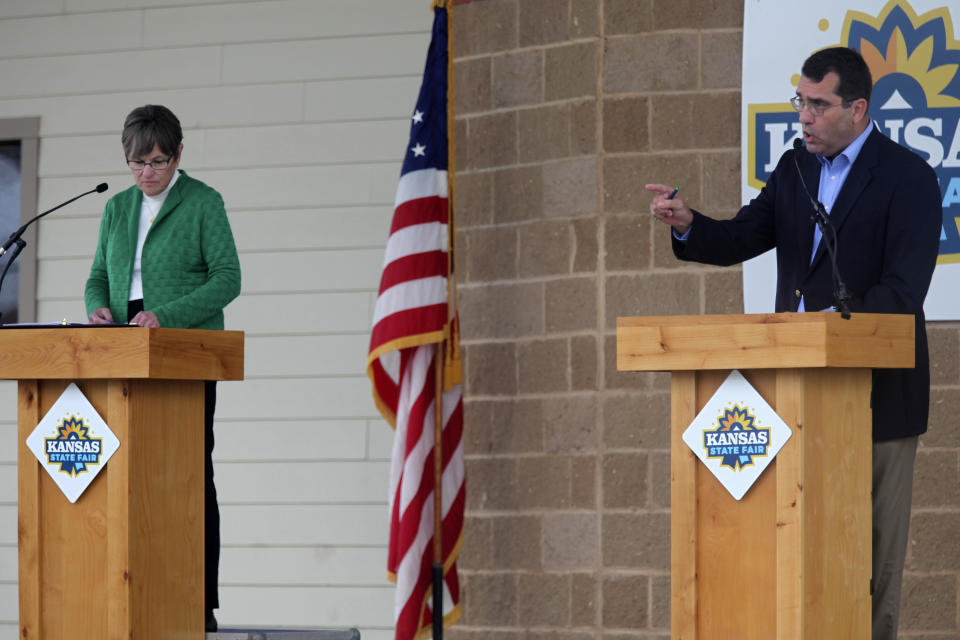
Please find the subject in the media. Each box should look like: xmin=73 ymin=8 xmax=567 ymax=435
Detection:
xmin=683 ymin=371 xmax=793 ymax=500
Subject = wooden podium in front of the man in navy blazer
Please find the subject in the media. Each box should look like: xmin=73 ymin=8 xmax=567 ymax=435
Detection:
xmin=617 ymin=313 xmax=914 ymax=640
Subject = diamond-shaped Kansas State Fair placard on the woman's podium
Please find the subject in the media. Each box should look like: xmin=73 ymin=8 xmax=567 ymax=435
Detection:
xmin=27 ymin=382 xmax=120 ymax=502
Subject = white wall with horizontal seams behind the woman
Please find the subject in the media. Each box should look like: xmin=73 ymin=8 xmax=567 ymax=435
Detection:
xmin=0 ymin=0 xmax=432 ymax=640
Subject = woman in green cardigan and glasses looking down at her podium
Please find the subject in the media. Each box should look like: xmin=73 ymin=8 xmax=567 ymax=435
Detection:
xmin=85 ymin=105 xmax=240 ymax=631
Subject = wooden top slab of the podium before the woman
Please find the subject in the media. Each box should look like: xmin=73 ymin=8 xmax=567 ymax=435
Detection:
xmin=0 ymin=326 xmax=244 ymax=380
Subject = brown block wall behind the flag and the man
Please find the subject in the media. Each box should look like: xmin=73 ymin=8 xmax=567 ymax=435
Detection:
xmin=450 ymin=0 xmax=960 ymax=640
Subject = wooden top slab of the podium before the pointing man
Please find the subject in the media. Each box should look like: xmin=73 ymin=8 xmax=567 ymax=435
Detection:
xmin=617 ymin=312 xmax=916 ymax=371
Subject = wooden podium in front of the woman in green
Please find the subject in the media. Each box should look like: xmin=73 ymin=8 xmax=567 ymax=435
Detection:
xmin=0 ymin=327 xmax=243 ymax=640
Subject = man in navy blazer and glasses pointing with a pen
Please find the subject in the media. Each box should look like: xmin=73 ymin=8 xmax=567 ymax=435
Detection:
xmin=646 ymin=47 xmax=942 ymax=640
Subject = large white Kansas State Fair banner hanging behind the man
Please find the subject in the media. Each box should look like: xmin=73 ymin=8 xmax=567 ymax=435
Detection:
xmin=741 ymin=0 xmax=960 ymax=320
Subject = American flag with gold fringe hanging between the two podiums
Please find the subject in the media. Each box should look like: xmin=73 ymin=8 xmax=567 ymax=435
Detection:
xmin=367 ymin=2 xmax=465 ymax=640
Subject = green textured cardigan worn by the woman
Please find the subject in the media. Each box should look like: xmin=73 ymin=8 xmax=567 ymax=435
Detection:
xmin=84 ymin=171 xmax=240 ymax=329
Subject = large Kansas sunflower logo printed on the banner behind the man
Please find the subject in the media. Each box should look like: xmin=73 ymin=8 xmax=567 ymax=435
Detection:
xmin=747 ymin=0 xmax=960 ymax=264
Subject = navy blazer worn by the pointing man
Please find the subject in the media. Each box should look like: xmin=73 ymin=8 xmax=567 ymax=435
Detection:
xmin=673 ymin=129 xmax=943 ymax=441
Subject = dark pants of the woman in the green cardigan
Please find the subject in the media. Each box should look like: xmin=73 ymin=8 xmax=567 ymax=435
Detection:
xmin=127 ymin=300 xmax=220 ymax=611
